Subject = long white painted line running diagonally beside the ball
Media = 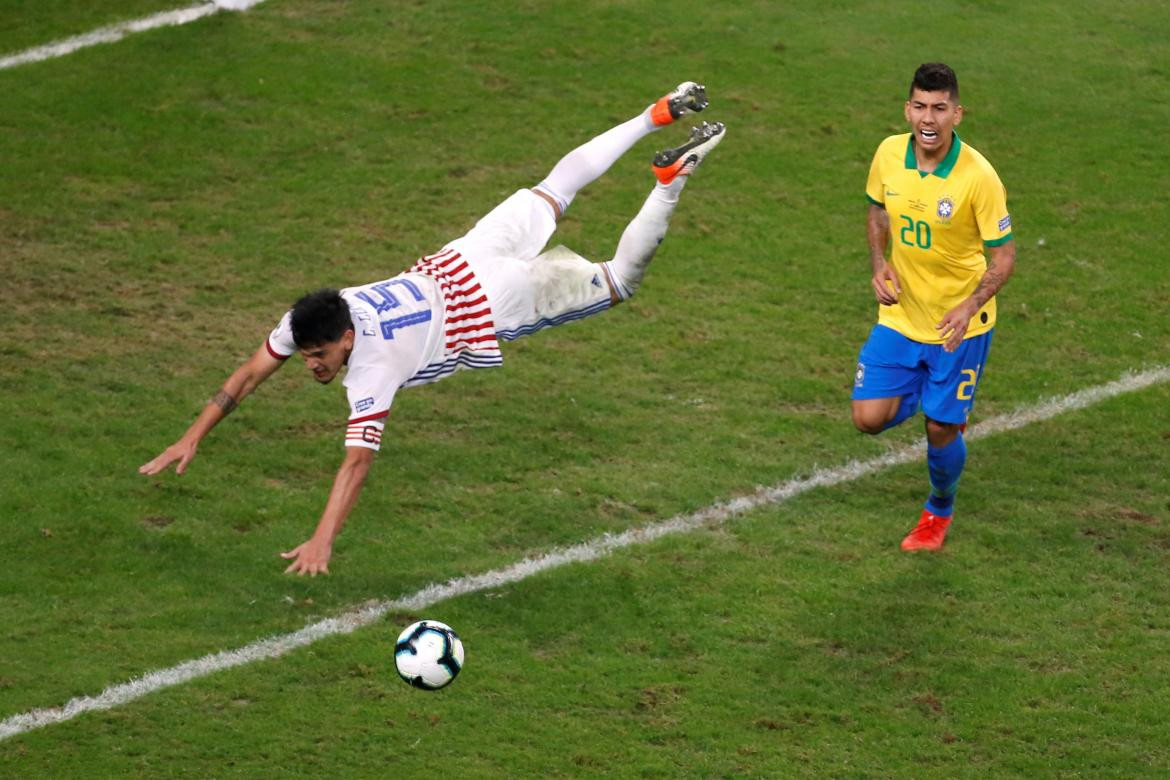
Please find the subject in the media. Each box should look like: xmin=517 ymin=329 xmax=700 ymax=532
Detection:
xmin=0 ymin=366 xmax=1170 ymax=740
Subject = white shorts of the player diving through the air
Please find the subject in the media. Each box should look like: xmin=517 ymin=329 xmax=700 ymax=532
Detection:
xmin=445 ymin=189 xmax=610 ymax=341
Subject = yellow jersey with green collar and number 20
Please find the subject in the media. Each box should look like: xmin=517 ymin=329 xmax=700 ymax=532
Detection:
xmin=866 ymin=133 xmax=1012 ymax=344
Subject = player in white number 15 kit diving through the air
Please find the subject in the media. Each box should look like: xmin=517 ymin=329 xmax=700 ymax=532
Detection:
xmin=139 ymin=82 xmax=724 ymax=575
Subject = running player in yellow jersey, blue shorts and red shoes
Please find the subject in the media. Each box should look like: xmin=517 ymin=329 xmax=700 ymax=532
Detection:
xmin=853 ymin=62 xmax=1016 ymax=550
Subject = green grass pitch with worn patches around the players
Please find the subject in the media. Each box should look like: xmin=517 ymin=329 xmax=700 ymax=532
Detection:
xmin=0 ymin=0 xmax=1170 ymax=779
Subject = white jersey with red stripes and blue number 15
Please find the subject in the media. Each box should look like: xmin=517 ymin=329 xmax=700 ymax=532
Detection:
xmin=267 ymin=250 xmax=503 ymax=450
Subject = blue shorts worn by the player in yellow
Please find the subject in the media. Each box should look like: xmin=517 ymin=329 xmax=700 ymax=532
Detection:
xmin=853 ymin=325 xmax=995 ymax=424
